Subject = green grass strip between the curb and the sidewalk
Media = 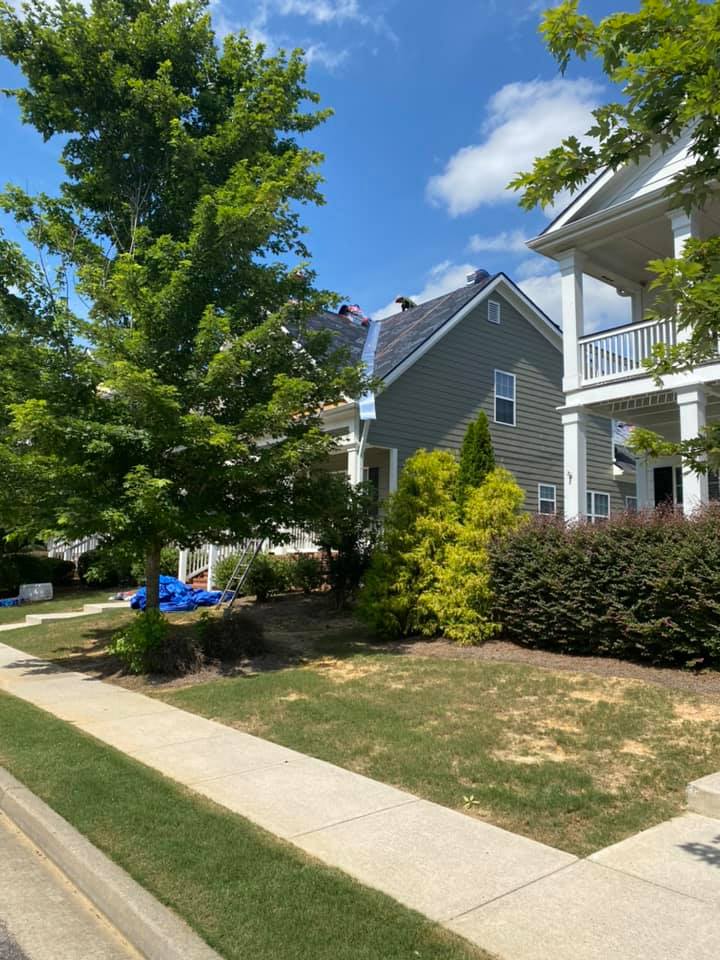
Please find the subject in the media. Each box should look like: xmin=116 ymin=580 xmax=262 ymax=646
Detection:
xmin=0 ymin=694 xmax=489 ymax=960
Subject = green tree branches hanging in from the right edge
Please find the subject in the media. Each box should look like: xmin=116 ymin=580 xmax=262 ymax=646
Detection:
xmin=510 ymin=0 xmax=720 ymax=469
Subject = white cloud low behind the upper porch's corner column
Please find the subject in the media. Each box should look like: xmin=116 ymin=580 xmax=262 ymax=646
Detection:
xmin=516 ymin=261 xmax=631 ymax=333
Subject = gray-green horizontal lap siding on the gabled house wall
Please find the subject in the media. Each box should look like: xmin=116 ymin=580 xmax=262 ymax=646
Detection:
xmin=369 ymin=294 xmax=625 ymax=513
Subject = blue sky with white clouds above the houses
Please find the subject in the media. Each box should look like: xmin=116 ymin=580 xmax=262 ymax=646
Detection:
xmin=0 ymin=0 xmax=634 ymax=327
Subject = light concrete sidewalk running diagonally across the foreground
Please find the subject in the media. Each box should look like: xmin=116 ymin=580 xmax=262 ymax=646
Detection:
xmin=0 ymin=644 xmax=720 ymax=960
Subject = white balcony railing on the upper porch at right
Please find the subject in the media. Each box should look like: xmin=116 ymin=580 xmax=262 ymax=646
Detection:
xmin=578 ymin=320 xmax=677 ymax=384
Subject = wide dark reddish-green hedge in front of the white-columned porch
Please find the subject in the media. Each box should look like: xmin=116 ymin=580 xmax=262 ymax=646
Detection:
xmin=491 ymin=507 xmax=720 ymax=666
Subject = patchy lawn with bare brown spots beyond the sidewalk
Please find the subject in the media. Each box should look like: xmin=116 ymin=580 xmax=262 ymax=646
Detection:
xmin=162 ymin=653 xmax=720 ymax=855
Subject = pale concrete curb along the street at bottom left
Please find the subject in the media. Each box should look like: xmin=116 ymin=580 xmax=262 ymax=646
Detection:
xmin=0 ymin=767 xmax=222 ymax=960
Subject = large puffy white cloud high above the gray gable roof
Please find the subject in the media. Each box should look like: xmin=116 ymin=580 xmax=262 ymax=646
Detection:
xmin=427 ymin=77 xmax=600 ymax=216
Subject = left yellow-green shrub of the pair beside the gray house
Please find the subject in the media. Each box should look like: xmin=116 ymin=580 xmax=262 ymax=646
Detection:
xmin=358 ymin=450 xmax=459 ymax=639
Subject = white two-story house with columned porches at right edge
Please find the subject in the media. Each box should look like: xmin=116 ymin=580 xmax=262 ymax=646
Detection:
xmin=529 ymin=131 xmax=720 ymax=519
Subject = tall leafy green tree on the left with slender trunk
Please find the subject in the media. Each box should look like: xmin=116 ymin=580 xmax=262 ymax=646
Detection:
xmin=0 ymin=0 xmax=362 ymax=607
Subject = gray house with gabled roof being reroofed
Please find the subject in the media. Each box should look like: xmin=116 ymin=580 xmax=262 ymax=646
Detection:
xmin=313 ymin=271 xmax=635 ymax=519
